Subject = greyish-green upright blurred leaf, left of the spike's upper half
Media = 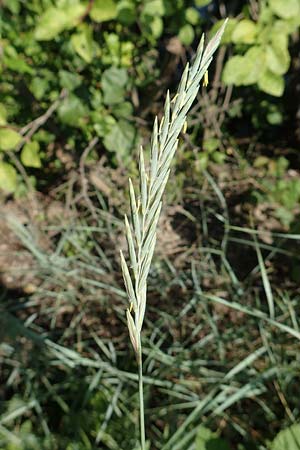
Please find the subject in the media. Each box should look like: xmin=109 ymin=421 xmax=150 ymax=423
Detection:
xmin=101 ymin=67 xmax=128 ymax=105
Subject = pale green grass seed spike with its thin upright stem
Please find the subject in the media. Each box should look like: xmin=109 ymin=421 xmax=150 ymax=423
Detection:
xmin=121 ymin=21 xmax=226 ymax=450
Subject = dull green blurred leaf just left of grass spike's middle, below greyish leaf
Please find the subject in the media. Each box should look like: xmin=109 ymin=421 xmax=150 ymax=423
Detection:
xmin=104 ymin=119 xmax=135 ymax=158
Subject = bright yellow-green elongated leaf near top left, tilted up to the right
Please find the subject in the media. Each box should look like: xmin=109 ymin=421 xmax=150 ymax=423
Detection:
xmin=34 ymin=2 xmax=86 ymax=41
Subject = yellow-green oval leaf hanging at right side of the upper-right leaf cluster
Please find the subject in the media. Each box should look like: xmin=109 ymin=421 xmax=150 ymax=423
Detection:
xmin=266 ymin=35 xmax=291 ymax=75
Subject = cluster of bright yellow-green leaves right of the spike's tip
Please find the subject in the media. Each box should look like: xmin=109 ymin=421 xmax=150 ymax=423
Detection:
xmin=217 ymin=0 xmax=300 ymax=97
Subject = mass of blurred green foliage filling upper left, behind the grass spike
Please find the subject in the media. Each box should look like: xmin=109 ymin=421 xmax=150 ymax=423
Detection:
xmin=0 ymin=0 xmax=204 ymax=192
